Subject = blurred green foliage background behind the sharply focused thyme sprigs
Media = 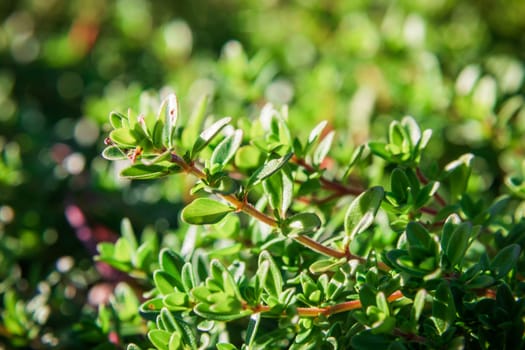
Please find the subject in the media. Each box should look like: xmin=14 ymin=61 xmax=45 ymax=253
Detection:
xmin=0 ymin=0 xmax=525 ymax=347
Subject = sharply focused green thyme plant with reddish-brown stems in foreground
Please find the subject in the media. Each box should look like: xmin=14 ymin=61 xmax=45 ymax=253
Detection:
xmin=97 ymin=94 xmax=525 ymax=350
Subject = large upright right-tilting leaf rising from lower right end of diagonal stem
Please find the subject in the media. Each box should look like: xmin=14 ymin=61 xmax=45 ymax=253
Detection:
xmin=344 ymin=186 xmax=384 ymax=239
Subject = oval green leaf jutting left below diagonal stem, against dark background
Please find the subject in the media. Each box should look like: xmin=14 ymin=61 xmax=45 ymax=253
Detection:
xmin=182 ymin=198 xmax=234 ymax=225
